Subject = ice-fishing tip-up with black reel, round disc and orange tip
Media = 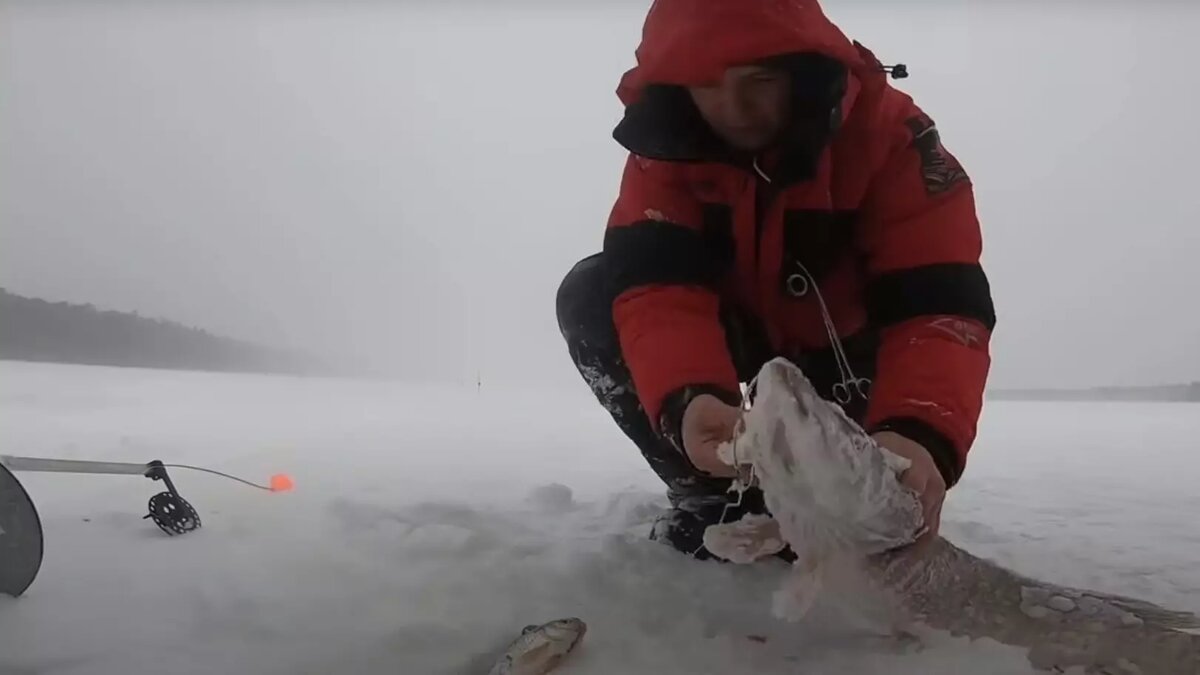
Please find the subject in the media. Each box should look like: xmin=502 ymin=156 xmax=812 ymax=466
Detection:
xmin=0 ymin=455 xmax=294 ymax=597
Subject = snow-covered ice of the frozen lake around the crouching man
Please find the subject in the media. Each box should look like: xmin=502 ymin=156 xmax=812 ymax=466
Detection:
xmin=0 ymin=356 xmax=1200 ymax=675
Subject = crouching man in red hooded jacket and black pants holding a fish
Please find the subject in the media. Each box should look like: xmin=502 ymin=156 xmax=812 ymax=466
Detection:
xmin=557 ymin=0 xmax=996 ymax=558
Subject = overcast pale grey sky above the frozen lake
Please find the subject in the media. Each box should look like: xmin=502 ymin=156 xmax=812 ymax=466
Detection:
xmin=0 ymin=0 xmax=1200 ymax=387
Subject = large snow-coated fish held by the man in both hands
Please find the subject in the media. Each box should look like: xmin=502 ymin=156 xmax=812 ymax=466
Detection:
xmin=706 ymin=359 xmax=1200 ymax=675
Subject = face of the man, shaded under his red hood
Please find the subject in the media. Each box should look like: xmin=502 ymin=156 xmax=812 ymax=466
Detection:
xmin=688 ymin=66 xmax=791 ymax=153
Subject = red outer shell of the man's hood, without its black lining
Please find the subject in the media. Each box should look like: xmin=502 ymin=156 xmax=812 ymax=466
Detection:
xmin=617 ymin=0 xmax=871 ymax=106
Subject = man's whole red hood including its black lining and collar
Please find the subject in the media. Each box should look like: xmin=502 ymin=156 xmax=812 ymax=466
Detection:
xmin=613 ymin=0 xmax=884 ymax=177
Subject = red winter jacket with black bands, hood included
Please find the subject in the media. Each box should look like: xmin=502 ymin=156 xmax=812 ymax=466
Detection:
xmin=605 ymin=0 xmax=996 ymax=485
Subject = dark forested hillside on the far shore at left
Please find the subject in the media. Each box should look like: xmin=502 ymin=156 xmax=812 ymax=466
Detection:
xmin=0 ymin=288 xmax=323 ymax=374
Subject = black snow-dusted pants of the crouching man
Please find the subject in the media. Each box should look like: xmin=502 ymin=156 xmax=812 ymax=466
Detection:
xmin=557 ymin=253 xmax=878 ymax=558
